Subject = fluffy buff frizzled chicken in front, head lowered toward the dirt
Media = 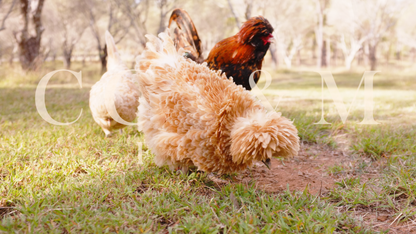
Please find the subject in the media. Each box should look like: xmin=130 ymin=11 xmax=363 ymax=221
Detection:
xmin=135 ymin=33 xmax=299 ymax=174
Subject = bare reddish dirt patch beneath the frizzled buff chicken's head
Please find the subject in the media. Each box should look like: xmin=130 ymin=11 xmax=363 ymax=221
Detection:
xmin=235 ymin=144 xmax=360 ymax=195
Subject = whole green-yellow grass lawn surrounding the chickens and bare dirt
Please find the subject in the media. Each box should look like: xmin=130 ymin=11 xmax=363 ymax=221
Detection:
xmin=0 ymin=61 xmax=416 ymax=233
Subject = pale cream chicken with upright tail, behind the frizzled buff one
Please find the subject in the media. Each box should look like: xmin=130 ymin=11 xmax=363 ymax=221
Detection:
xmin=90 ymin=31 xmax=140 ymax=137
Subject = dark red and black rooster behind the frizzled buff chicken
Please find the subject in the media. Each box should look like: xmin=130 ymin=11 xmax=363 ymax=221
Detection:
xmin=169 ymin=9 xmax=274 ymax=90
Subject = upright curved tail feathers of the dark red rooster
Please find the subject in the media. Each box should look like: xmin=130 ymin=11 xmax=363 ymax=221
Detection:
xmin=168 ymin=8 xmax=204 ymax=63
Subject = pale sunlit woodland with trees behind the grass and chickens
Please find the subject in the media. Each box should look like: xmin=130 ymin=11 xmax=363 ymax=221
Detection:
xmin=0 ymin=0 xmax=416 ymax=70
